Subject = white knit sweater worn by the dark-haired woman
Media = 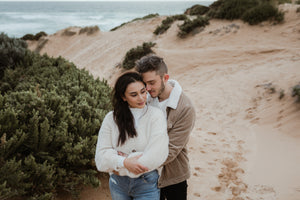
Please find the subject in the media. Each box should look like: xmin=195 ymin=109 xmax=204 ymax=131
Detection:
xmin=95 ymin=106 xmax=169 ymax=178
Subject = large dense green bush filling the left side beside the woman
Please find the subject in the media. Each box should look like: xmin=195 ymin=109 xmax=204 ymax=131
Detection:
xmin=0 ymin=35 xmax=112 ymax=200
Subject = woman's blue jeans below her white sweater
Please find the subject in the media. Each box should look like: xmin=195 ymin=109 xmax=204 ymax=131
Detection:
xmin=109 ymin=170 xmax=160 ymax=200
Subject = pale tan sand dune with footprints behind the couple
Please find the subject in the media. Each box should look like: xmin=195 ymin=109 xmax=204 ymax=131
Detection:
xmin=29 ymin=4 xmax=300 ymax=200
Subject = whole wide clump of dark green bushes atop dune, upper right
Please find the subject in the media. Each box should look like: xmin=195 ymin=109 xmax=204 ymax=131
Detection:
xmin=207 ymin=0 xmax=284 ymax=25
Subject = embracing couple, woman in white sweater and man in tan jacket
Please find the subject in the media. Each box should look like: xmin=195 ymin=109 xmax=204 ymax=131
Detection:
xmin=95 ymin=55 xmax=195 ymax=200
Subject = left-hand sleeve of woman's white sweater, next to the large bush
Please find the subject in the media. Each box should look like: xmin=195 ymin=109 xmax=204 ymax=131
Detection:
xmin=95 ymin=112 xmax=124 ymax=172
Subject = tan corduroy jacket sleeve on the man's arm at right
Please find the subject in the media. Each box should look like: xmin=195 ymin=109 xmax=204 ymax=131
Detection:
xmin=164 ymin=101 xmax=196 ymax=165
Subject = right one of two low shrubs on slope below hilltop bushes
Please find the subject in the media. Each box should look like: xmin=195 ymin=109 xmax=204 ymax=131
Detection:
xmin=178 ymin=16 xmax=209 ymax=38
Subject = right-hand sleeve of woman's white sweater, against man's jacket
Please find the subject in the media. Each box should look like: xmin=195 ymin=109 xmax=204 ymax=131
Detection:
xmin=139 ymin=108 xmax=169 ymax=171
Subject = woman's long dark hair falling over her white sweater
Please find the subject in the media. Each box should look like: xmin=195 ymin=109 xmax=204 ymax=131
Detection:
xmin=112 ymin=72 xmax=145 ymax=145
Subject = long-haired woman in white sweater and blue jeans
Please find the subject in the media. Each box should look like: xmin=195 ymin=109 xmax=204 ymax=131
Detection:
xmin=95 ymin=72 xmax=169 ymax=200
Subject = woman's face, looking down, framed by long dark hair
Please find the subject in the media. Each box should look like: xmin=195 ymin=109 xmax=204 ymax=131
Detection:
xmin=123 ymin=82 xmax=147 ymax=108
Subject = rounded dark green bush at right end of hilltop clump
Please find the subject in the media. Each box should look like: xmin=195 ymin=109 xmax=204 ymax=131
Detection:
xmin=242 ymin=3 xmax=284 ymax=25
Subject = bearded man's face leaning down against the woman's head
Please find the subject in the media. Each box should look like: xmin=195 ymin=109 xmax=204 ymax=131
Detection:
xmin=142 ymin=71 xmax=165 ymax=98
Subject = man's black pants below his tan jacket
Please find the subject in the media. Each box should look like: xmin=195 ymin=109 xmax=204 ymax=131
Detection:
xmin=160 ymin=181 xmax=187 ymax=200
